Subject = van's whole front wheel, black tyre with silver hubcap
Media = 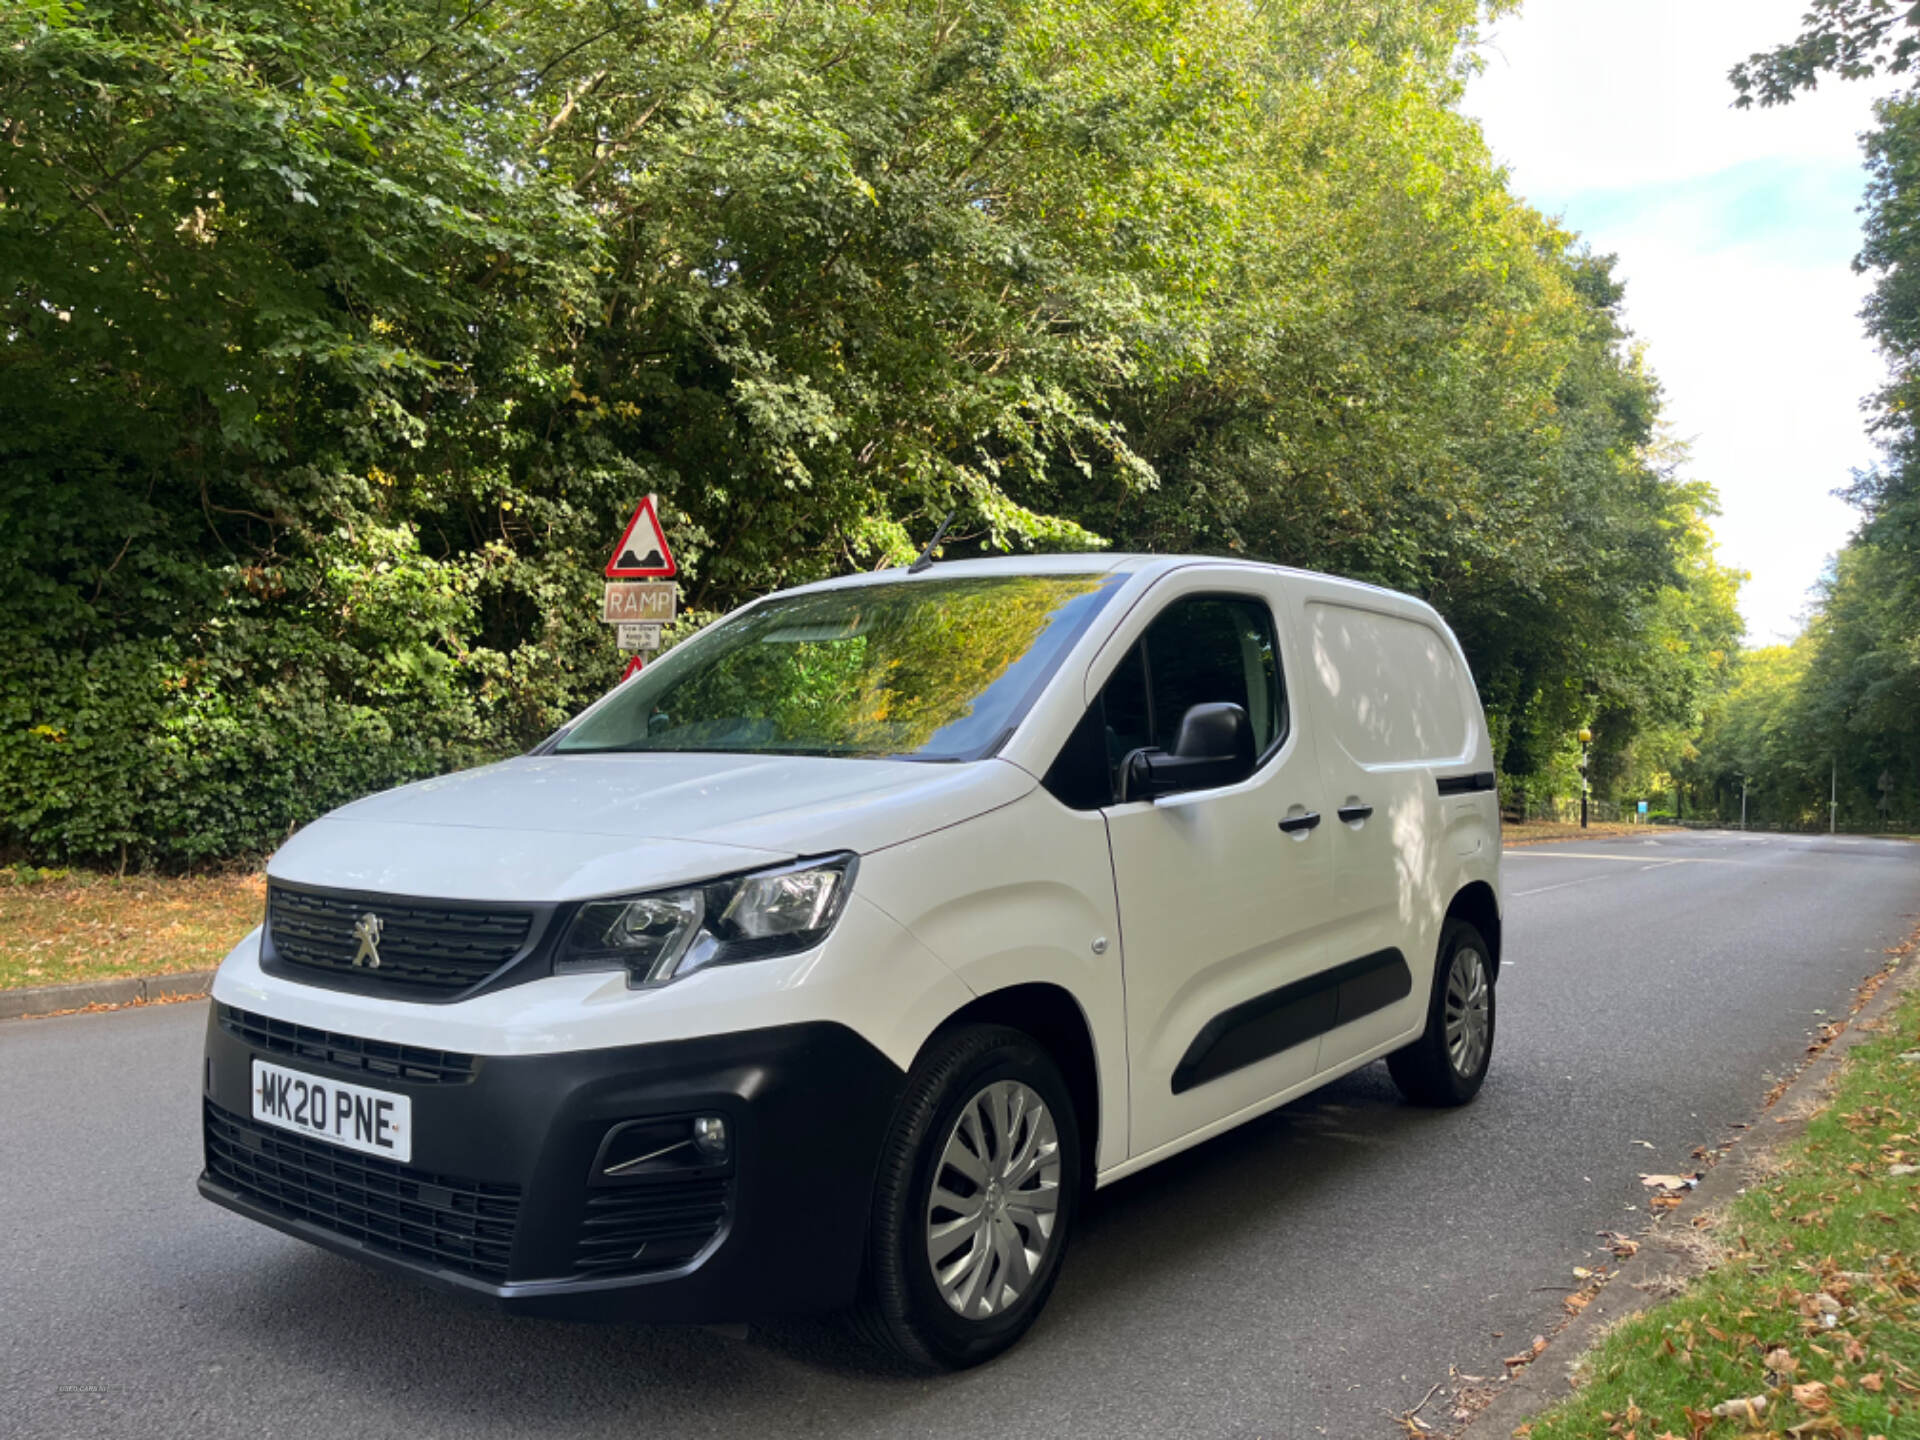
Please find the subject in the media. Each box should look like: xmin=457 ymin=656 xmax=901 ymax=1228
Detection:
xmin=856 ymin=1025 xmax=1081 ymax=1369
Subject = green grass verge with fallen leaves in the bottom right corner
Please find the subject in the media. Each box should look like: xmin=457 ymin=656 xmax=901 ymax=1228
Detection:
xmin=1515 ymin=971 xmax=1920 ymax=1440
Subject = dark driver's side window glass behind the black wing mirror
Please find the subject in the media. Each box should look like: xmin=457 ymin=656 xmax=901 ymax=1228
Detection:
xmin=1044 ymin=595 xmax=1286 ymax=810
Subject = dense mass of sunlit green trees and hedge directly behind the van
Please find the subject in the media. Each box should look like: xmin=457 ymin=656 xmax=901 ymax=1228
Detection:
xmin=0 ymin=0 xmax=1734 ymax=860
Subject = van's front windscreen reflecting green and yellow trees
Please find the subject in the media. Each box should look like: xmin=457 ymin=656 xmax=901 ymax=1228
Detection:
xmin=553 ymin=574 xmax=1121 ymax=760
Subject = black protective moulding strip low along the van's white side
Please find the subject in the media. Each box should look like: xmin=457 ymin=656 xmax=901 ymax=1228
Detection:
xmin=1173 ymin=950 xmax=1413 ymax=1094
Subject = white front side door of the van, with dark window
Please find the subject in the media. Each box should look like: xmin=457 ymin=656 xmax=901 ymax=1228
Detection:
xmin=1094 ymin=572 xmax=1332 ymax=1158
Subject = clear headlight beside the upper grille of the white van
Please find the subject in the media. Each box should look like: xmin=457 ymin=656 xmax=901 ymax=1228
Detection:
xmin=553 ymin=854 xmax=858 ymax=985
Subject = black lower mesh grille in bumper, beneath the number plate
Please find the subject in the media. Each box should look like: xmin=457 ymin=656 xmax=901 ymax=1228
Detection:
xmin=205 ymin=1100 xmax=520 ymax=1283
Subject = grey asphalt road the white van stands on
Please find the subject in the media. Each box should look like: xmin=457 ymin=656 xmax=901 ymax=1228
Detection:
xmin=0 ymin=833 xmax=1920 ymax=1440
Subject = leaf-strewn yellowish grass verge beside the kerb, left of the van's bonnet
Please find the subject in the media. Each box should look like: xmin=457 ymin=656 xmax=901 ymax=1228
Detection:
xmin=0 ymin=866 xmax=267 ymax=989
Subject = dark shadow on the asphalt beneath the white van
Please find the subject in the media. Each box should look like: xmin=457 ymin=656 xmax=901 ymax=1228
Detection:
xmin=192 ymin=1066 xmax=1446 ymax=1436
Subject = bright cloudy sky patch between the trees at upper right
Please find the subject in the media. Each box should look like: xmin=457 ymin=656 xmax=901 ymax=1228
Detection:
xmin=1463 ymin=0 xmax=1885 ymax=645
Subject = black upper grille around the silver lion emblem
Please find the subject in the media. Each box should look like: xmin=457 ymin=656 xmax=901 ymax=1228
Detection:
xmin=267 ymin=885 xmax=534 ymax=993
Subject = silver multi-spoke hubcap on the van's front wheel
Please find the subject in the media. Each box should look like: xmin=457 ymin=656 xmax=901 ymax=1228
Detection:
xmin=927 ymin=1081 xmax=1060 ymax=1319
